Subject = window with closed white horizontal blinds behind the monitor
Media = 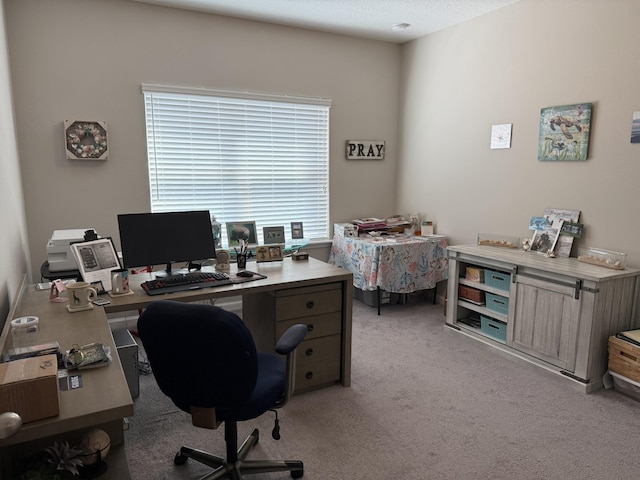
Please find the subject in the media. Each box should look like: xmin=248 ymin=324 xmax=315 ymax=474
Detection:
xmin=142 ymin=84 xmax=330 ymax=246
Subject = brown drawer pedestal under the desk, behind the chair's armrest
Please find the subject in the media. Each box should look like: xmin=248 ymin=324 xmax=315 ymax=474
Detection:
xmin=242 ymin=282 xmax=344 ymax=393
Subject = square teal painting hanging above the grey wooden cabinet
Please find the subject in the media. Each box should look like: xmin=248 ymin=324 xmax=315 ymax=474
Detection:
xmin=538 ymin=103 xmax=592 ymax=161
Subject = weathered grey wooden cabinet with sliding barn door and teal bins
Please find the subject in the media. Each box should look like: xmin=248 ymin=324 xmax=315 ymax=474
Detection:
xmin=446 ymin=245 xmax=640 ymax=392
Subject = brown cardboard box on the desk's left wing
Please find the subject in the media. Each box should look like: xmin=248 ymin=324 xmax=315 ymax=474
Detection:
xmin=0 ymin=355 xmax=60 ymax=423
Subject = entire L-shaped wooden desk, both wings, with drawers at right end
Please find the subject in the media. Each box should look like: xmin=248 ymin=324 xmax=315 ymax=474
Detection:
xmin=0 ymin=258 xmax=353 ymax=480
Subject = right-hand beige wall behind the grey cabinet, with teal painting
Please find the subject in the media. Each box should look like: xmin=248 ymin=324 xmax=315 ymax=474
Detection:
xmin=397 ymin=0 xmax=640 ymax=267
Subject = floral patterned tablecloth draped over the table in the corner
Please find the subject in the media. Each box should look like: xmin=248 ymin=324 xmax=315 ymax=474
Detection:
xmin=329 ymin=235 xmax=449 ymax=293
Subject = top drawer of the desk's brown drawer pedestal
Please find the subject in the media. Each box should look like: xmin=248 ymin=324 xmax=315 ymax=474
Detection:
xmin=275 ymin=289 xmax=342 ymax=322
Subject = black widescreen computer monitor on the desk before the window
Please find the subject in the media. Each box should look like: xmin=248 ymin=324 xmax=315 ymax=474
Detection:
xmin=118 ymin=210 xmax=216 ymax=275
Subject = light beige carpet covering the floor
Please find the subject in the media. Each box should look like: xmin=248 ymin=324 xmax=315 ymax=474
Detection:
xmin=124 ymin=296 xmax=640 ymax=480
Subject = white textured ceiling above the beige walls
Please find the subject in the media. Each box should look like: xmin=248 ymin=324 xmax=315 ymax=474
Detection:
xmin=134 ymin=0 xmax=518 ymax=43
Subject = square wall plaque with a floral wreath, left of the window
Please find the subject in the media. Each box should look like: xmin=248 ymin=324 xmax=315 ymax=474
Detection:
xmin=64 ymin=120 xmax=107 ymax=160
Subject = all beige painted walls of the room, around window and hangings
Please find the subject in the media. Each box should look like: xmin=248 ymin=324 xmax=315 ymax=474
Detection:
xmin=7 ymin=0 xmax=640 ymax=286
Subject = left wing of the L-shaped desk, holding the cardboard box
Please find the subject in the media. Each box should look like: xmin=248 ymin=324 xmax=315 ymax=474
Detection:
xmin=0 ymin=276 xmax=133 ymax=480
